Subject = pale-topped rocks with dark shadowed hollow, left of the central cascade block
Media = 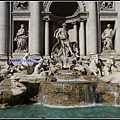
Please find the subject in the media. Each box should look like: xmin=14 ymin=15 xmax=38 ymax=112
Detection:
xmin=0 ymin=73 xmax=55 ymax=108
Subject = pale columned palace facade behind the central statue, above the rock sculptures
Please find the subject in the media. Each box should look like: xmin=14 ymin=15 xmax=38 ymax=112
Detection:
xmin=0 ymin=1 xmax=120 ymax=63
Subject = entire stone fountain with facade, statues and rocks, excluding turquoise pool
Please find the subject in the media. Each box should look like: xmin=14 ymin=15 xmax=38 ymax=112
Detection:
xmin=0 ymin=1 xmax=120 ymax=118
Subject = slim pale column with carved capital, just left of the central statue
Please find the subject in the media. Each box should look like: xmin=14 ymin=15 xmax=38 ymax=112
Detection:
xmin=44 ymin=16 xmax=50 ymax=56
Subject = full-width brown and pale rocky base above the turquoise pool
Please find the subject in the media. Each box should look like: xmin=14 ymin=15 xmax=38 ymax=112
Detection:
xmin=0 ymin=72 xmax=120 ymax=108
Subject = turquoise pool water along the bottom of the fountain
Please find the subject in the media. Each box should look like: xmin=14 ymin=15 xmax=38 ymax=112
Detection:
xmin=0 ymin=104 xmax=120 ymax=118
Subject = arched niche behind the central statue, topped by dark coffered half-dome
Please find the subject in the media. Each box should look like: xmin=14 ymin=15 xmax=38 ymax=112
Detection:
xmin=42 ymin=1 xmax=87 ymax=56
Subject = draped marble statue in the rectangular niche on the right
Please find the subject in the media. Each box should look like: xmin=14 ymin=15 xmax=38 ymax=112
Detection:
xmin=102 ymin=24 xmax=117 ymax=51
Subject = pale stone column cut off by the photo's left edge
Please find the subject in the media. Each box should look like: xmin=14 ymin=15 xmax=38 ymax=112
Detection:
xmin=0 ymin=1 xmax=8 ymax=56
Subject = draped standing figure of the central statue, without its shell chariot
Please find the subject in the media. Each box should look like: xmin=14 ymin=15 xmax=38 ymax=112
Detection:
xmin=54 ymin=23 xmax=73 ymax=56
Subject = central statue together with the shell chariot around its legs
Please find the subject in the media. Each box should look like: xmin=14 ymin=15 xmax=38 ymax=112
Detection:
xmin=52 ymin=23 xmax=76 ymax=57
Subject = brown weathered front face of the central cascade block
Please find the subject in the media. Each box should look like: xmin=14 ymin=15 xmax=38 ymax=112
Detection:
xmin=38 ymin=82 xmax=96 ymax=106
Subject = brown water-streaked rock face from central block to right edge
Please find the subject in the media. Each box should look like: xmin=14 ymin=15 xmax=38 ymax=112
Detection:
xmin=38 ymin=79 xmax=120 ymax=106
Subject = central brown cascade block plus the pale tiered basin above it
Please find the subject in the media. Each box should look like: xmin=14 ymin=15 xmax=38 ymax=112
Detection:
xmin=38 ymin=70 xmax=97 ymax=106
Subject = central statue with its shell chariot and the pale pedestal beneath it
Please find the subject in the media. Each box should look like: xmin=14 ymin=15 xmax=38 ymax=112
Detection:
xmin=51 ymin=23 xmax=79 ymax=68
